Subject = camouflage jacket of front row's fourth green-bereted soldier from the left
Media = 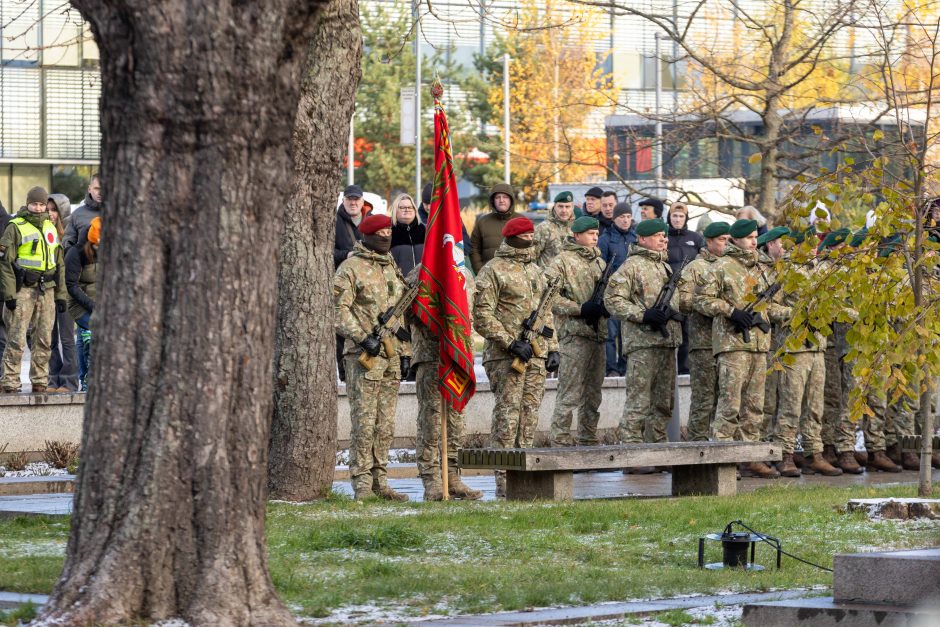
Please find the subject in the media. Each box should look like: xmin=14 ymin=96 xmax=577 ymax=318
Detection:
xmin=692 ymin=244 xmax=790 ymax=356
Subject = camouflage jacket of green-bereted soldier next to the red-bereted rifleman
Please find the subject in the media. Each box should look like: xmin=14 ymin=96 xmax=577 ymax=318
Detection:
xmin=546 ymin=241 xmax=607 ymax=343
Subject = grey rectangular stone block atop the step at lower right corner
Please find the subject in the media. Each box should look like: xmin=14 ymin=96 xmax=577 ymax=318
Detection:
xmin=832 ymin=549 xmax=940 ymax=606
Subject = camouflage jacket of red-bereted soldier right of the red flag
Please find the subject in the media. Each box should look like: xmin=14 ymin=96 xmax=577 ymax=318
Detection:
xmin=473 ymin=242 xmax=558 ymax=363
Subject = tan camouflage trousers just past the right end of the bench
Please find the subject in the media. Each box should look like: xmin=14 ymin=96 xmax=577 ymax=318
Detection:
xmin=764 ymin=351 xmax=826 ymax=454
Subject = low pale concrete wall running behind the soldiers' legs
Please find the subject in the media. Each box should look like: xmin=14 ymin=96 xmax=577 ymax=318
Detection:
xmin=0 ymin=376 xmax=689 ymax=453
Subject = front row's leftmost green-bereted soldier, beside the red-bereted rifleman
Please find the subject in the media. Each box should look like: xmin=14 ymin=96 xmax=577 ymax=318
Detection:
xmin=547 ymin=216 xmax=607 ymax=446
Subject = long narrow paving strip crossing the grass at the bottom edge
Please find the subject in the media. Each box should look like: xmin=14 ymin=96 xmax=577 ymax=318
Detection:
xmin=411 ymin=590 xmax=815 ymax=627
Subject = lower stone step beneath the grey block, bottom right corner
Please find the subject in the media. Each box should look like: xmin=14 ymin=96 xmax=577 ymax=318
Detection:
xmin=741 ymin=596 xmax=940 ymax=627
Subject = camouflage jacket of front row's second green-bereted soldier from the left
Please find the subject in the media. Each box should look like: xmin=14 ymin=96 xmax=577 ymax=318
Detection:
xmin=604 ymin=244 xmax=682 ymax=355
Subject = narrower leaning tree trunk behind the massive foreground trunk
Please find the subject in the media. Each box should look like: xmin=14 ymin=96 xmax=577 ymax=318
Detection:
xmin=268 ymin=0 xmax=362 ymax=501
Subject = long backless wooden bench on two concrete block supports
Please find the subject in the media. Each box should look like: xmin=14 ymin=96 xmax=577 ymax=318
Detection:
xmin=457 ymin=442 xmax=781 ymax=501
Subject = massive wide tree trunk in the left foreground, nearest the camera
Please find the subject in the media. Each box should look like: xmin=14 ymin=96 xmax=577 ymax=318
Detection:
xmin=43 ymin=0 xmax=322 ymax=625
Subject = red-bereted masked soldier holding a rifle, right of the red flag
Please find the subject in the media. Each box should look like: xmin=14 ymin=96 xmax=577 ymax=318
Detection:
xmin=473 ymin=217 xmax=560 ymax=496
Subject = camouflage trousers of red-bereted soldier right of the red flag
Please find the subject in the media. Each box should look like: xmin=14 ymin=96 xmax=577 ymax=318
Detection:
xmin=483 ymin=358 xmax=546 ymax=486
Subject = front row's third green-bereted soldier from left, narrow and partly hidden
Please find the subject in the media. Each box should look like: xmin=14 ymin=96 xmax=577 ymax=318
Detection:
xmin=678 ymin=222 xmax=731 ymax=442
